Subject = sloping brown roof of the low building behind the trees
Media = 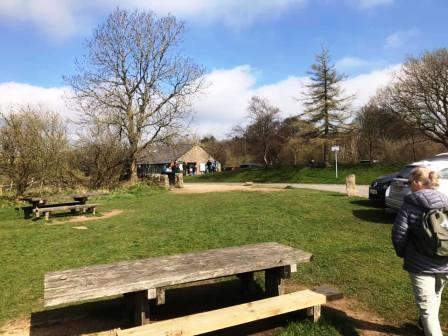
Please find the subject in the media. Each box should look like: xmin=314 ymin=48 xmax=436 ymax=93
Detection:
xmin=137 ymin=144 xmax=197 ymax=164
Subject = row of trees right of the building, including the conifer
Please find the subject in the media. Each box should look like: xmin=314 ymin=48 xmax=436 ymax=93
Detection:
xmin=202 ymin=48 xmax=448 ymax=166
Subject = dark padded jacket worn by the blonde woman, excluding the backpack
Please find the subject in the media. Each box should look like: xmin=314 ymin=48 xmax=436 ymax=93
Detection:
xmin=392 ymin=189 xmax=448 ymax=274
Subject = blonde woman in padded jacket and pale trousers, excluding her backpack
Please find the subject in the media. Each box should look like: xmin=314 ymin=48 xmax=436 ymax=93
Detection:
xmin=392 ymin=168 xmax=448 ymax=336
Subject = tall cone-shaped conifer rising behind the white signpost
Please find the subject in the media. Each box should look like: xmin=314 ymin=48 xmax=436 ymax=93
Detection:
xmin=301 ymin=49 xmax=353 ymax=164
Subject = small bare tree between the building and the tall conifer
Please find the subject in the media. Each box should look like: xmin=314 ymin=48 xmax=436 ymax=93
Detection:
xmin=245 ymin=96 xmax=280 ymax=165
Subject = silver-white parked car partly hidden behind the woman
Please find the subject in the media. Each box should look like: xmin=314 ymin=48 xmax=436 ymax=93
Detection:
xmin=386 ymin=157 xmax=448 ymax=211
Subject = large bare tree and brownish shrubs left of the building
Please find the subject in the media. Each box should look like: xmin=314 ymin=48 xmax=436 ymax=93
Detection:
xmin=0 ymin=8 xmax=204 ymax=195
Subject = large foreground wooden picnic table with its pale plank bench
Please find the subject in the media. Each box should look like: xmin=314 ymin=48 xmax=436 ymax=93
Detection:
xmin=44 ymin=242 xmax=342 ymax=335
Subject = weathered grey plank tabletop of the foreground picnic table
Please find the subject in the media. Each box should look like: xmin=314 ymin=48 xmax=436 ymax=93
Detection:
xmin=44 ymin=243 xmax=312 ymax=306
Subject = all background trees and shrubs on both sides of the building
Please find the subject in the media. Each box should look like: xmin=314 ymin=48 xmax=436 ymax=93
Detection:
xmin=0 ymin=8 xmax=448 ymax=195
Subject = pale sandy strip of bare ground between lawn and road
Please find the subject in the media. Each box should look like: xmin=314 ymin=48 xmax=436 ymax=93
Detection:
xmin=172 ymin=183 xmax=284 ymax=194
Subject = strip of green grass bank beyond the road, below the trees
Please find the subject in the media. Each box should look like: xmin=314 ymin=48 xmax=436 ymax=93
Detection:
xmin=185 ymin=164 xmax=403 ymax=184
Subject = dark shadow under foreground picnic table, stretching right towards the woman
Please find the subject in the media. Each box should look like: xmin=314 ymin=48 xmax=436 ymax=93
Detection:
xmin=30 ymin=280 xmax=418 ymax=336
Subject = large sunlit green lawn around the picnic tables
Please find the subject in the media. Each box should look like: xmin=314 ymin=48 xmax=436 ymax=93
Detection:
xmin=0 ymin=188 xmax=448 ymax=336
